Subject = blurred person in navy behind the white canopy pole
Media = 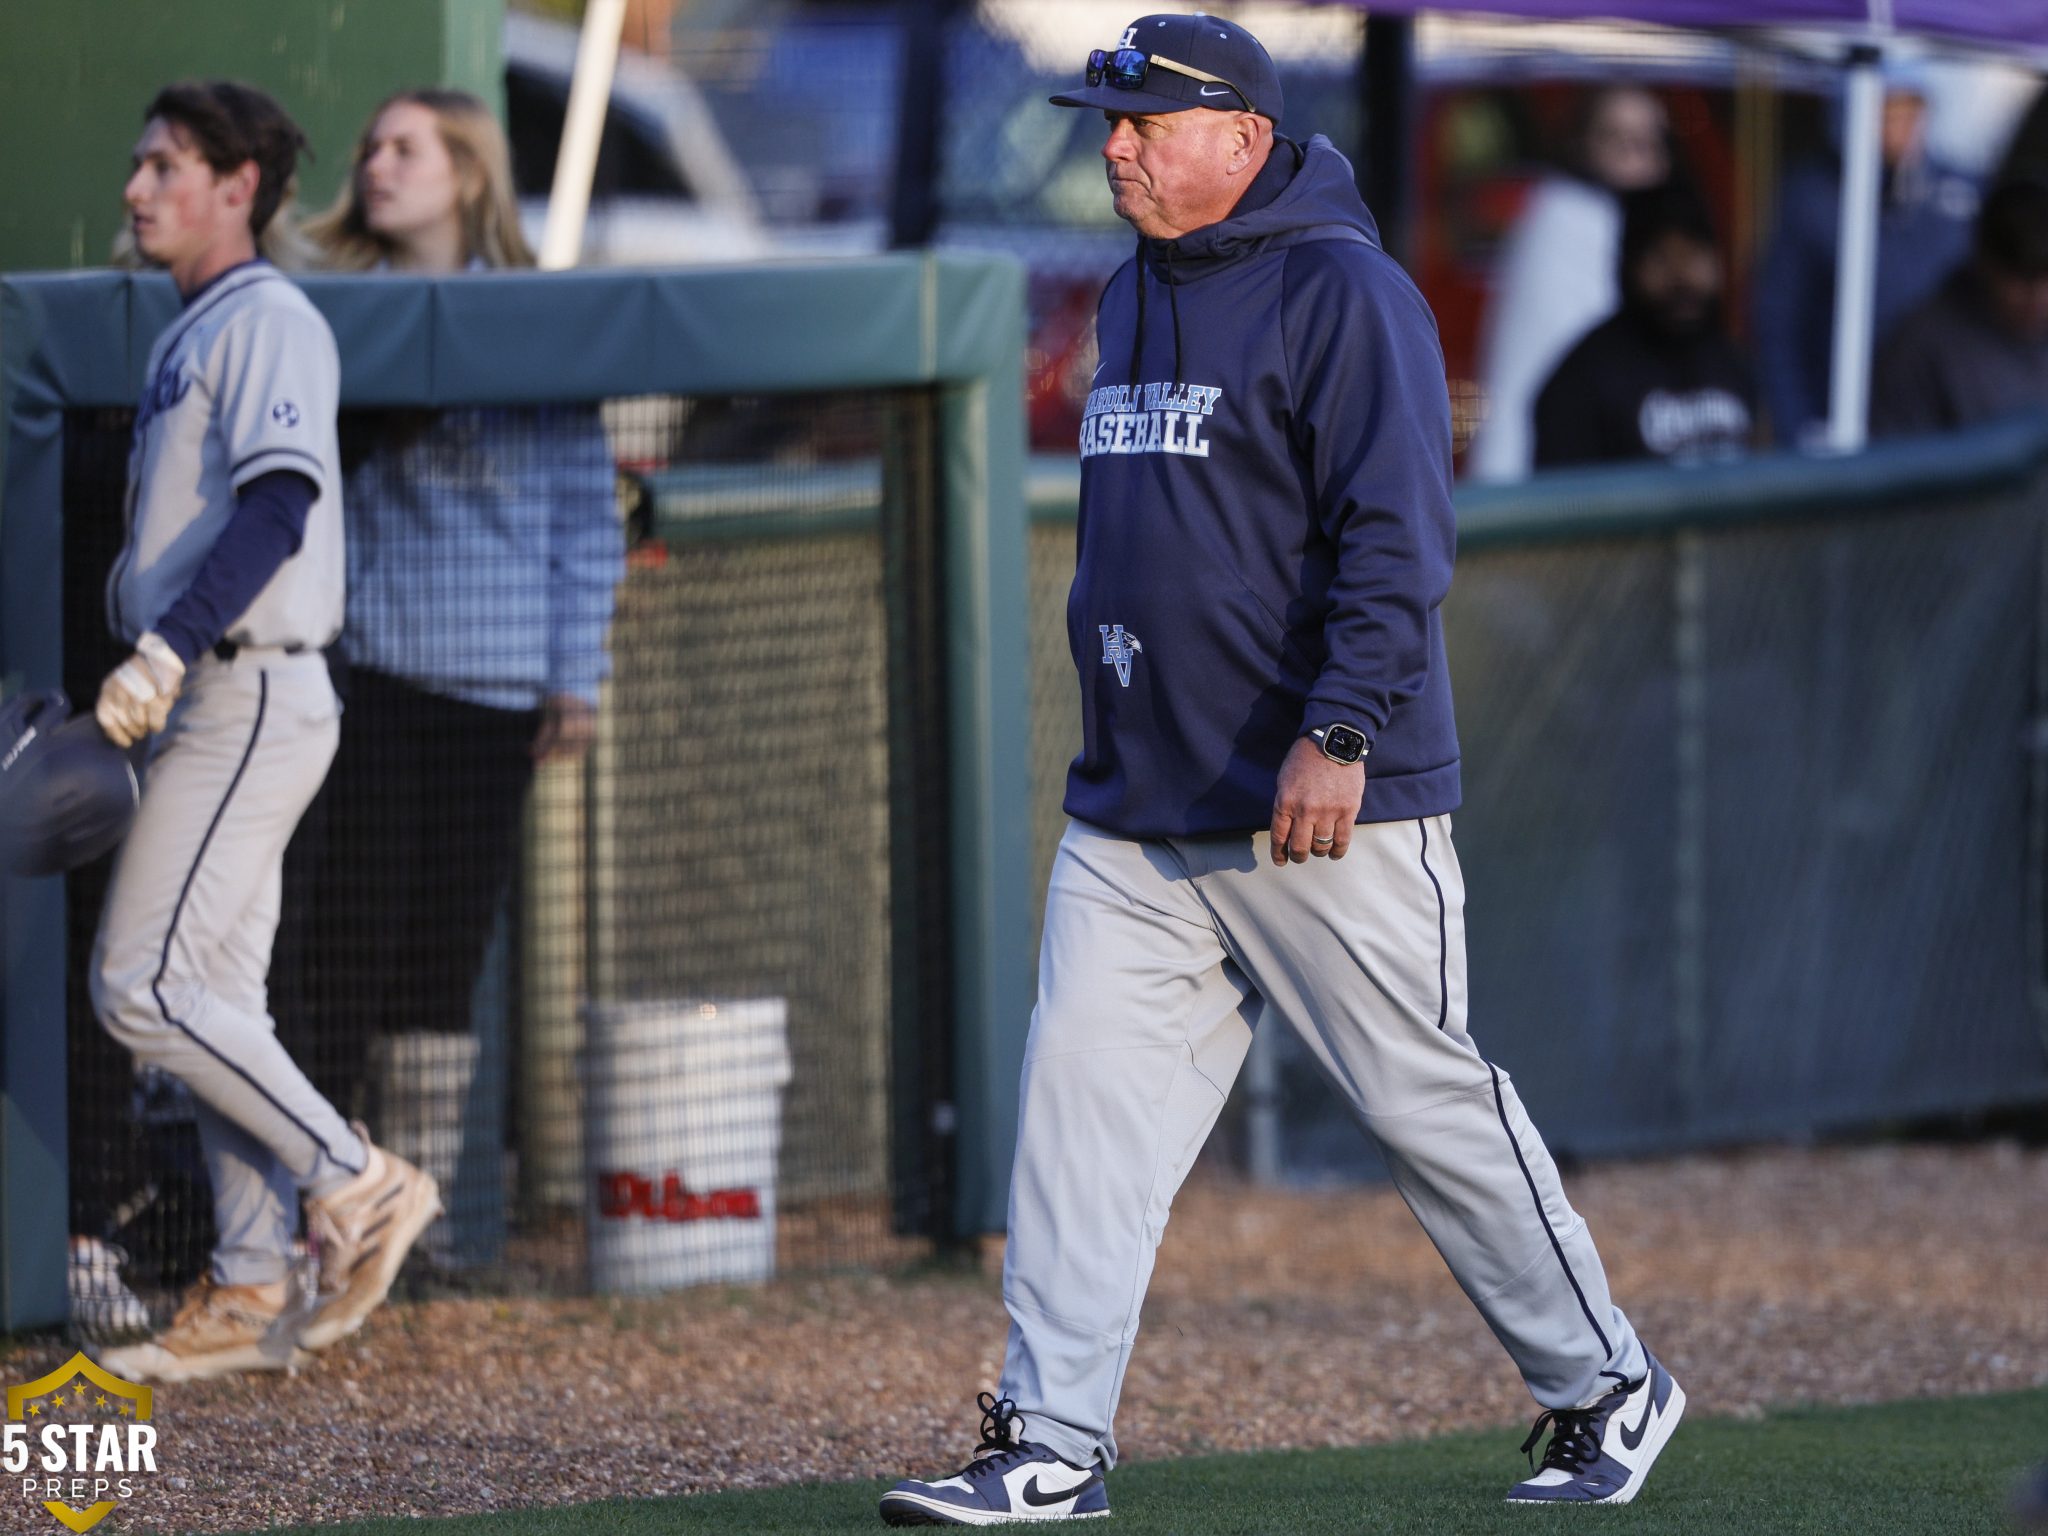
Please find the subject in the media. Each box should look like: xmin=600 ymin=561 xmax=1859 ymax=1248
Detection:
xmin=1753 ymin=74 xmax=1976 ymax=446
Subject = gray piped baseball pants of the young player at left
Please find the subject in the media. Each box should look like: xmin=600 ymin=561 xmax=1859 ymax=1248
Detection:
xmin=92 ymin=649 xmax=365 ymax=1286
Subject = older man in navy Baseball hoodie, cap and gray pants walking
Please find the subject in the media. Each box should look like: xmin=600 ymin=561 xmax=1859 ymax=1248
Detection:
xmin=881 ymin=14 xmax=1686 ymax=1524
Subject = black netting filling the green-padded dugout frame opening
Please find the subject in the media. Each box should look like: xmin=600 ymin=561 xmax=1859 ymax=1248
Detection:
xmin=66 ymin=393 xmax=950 ymax=1325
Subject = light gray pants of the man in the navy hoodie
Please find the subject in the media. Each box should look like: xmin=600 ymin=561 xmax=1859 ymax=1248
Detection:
xmin=1001 ymin=817 xmax=1645 ymax=1466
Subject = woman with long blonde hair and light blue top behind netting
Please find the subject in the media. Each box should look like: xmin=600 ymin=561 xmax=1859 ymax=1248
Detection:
xmin=292 ymin=90 xmax=623 ymax=1257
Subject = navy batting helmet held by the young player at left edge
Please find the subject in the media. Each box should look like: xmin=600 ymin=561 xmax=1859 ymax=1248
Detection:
xmin=0 ymin=688 xmax=141 ymax=874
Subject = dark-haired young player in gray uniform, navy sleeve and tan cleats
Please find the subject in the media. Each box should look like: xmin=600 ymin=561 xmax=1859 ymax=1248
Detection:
xmin=92 ymin=82 xmax=440 ymax=1380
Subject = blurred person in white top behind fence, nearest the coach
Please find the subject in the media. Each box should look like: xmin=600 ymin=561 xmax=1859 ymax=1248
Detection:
xmin=1466 ymin=86 xmax=1671 ymax=479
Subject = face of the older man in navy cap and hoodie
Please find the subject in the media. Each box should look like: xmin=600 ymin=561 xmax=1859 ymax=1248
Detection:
xmin=1102 ymin=106 xmax=1272 ymax=240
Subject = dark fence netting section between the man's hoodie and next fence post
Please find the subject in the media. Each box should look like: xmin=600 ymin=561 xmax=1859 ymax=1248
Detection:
xmin=1441 ymin=539 xmax=1677 ymax=1155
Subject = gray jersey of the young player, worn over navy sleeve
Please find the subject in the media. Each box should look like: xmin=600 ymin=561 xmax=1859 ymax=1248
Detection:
xmin=106 ymin=262 xmax=344 ymax=649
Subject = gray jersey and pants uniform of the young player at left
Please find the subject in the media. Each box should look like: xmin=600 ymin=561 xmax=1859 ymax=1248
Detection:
xmin=92 ymin=262 xmax=367 ymax=1286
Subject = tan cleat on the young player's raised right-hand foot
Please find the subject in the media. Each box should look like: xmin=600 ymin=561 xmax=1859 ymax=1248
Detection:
xmin=299 ymin=1124 xmax=440 ymax=1350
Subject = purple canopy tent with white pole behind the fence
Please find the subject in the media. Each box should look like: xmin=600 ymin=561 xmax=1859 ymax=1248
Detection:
xmin=1348 ymin=0 xmax=2048 ymax=453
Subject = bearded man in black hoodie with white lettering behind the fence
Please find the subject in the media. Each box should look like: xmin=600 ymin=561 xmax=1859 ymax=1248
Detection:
xmin=1536 ymin=182 xmax=1757 ymax=469
